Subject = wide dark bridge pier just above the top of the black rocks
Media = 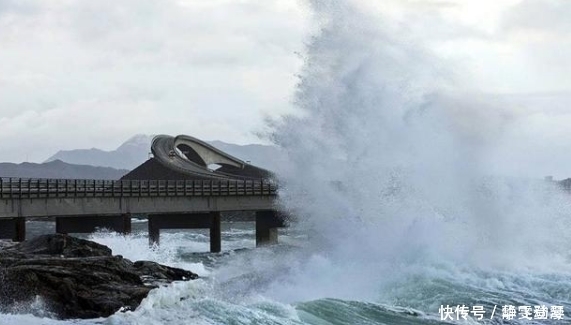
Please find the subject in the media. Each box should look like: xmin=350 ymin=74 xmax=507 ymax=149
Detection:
xmin=56 ymin=214 xmax=131 ymax=234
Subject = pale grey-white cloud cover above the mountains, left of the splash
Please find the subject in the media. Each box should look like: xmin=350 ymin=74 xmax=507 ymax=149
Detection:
xmin=0 ymin=0 xmax=307 ymax=161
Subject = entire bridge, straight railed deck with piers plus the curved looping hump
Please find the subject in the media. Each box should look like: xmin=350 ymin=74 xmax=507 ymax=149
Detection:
xmin=0 ymin=135 xmax=284 ymax=252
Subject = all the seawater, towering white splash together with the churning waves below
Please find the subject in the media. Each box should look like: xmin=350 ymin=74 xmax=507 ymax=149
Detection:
xmin=4 ymin=0 xmax=571 ymax=324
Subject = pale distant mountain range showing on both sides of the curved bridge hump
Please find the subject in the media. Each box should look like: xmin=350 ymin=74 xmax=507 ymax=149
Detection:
xmin=46 ymin=134 xmax=283 ymax=170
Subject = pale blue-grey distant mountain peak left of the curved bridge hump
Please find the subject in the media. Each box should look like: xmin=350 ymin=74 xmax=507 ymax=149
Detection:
xmin=45 ymin=134 xmax=153 ymax=170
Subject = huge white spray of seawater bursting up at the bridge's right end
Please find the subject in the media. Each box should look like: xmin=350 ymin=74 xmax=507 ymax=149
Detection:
xmin=267 ymin=1 xmax=571 ymax=312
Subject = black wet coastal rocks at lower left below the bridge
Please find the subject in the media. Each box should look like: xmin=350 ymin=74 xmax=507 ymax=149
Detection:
xmin=0 ymin=235 xmax=198 ymax=319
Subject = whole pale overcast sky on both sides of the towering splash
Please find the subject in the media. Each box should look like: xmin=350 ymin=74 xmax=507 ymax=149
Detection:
xmin=0 ymin=0 xmax=571 ymax=176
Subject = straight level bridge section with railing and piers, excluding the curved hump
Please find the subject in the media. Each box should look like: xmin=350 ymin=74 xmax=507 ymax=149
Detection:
xmin=0 ymin=178 xmax=283 ymax=252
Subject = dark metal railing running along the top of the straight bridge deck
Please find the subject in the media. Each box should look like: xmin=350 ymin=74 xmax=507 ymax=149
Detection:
xmin=0 ymin=178 xmax=277 ymax=199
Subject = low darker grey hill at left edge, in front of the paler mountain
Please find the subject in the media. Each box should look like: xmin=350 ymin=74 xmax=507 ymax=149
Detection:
xmin=0 ymin=160 xmax=129 ymax=179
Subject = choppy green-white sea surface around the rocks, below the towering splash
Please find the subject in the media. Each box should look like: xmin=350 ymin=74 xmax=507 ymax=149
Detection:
xmin=0 ymin=215 xmax=571 ymax=324
